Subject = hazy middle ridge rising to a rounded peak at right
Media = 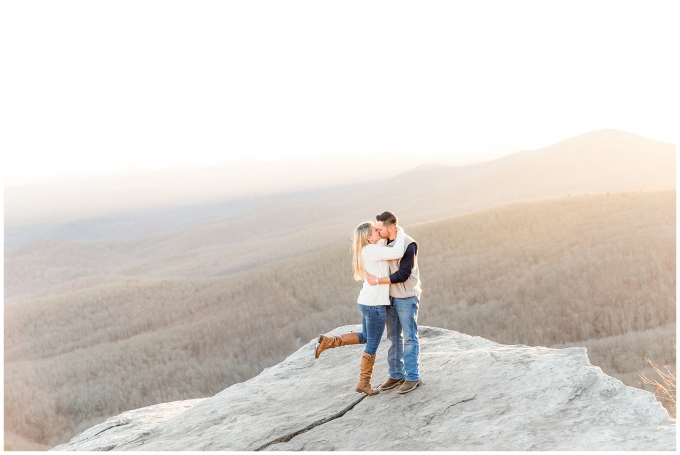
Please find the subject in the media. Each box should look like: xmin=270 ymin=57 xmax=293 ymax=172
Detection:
xmin=4 ymin=130 xmax=675 ymax=302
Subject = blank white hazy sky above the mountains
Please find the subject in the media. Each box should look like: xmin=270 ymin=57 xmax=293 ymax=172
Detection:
xmin=0 ymin=0 xmax=680 ymax=184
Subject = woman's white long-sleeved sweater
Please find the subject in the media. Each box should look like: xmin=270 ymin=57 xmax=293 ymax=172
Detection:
xmin=357 ymin=226 xmax=404 ymax=306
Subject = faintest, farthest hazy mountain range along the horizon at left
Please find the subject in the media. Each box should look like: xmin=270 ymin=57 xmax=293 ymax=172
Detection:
xmin=5 ymin=153 xmax=484 ymax=247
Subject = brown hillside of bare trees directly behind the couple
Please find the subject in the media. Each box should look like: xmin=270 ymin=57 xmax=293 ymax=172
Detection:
xmin=5 ymin=190 xmax=675 ymax=445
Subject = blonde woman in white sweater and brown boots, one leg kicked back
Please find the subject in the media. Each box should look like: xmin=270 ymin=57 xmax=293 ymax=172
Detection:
xmin=315 ymin=223 xmax=404 ymax=395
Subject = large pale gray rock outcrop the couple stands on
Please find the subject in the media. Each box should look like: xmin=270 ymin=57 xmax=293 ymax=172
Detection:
xmin=53 ymin=326 xmax=676 ymax=451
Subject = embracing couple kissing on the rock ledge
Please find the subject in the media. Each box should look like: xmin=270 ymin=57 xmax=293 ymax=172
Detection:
xmin=315 ymin=212 xmax=421 ymax=395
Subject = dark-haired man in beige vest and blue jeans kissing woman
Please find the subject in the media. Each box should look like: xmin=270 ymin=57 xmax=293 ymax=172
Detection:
xmin=366 ymin=212 xmax=421 ymax=394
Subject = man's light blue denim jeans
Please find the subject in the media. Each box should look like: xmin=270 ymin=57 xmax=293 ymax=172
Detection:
xmin=386 ymin=297 xmax=420 ymax=381
